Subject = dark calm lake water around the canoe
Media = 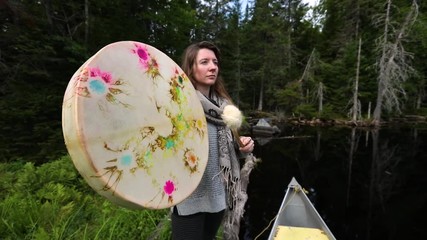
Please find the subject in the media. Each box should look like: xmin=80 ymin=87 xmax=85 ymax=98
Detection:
xmin=241 ymin=127 xmax=427 ymax=240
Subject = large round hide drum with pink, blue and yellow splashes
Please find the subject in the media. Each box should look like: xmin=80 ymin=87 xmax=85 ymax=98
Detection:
xmin=62 ymin=41 xmax=208 ymax=209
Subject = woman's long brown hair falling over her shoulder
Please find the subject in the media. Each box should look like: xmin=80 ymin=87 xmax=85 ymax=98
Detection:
xmin=181 ymin=41 xmax=232 ymax=102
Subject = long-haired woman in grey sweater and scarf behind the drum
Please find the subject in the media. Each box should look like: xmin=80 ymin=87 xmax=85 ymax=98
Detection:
xmin=172 ymin=41 xmax=254 ymax=240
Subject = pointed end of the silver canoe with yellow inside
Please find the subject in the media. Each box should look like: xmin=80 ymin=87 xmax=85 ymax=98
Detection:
xmin=268 ymin=178 xmax=335 ymax=240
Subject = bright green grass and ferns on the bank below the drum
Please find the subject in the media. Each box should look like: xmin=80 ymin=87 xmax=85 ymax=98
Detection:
xmin=0 ymin=157 xmax=170 ymax=239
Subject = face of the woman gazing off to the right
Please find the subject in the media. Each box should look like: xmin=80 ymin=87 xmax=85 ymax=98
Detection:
xmin=193 ymin=48 xmax=219 ymax=95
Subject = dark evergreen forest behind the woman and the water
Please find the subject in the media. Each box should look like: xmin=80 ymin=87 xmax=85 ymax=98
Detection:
xmin=0 ymin=0 xmax=427 ymax=164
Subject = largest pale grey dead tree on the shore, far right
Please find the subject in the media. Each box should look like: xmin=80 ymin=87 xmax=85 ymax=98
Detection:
xmin=373 ymin=0 xmax=418 ymax=125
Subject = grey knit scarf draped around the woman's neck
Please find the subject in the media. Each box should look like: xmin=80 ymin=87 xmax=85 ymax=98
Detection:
xmin=196 ymin=91 xmax=241 ymax=209
